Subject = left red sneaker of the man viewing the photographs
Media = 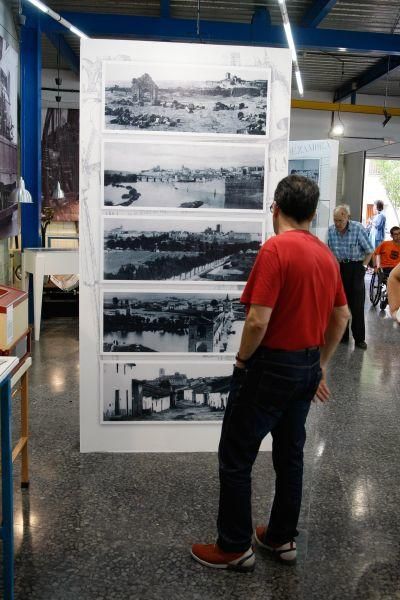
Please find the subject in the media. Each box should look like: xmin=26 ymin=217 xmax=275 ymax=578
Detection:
xmin=191 ymin=544 xmax=256 ymax=573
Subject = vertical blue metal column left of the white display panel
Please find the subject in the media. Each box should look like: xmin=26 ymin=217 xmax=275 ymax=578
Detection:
xmin=20 ymin=16 xmax=42 ymax=248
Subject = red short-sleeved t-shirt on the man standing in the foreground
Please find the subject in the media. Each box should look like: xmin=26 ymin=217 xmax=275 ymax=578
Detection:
xmin=241 ymin=229 xmax=347 ymax=350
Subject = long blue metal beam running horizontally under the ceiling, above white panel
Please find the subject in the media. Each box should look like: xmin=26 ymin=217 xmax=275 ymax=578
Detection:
xmin=32 ymin=11 xmax=400 ymax=56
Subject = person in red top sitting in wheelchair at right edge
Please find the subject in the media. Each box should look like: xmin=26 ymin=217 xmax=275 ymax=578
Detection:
xmin=370 ymin=226 xmax=400 ymax=310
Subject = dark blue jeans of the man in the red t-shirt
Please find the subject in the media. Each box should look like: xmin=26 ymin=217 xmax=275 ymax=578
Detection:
xmin=217 ymin=348 xmax=322 ymax=552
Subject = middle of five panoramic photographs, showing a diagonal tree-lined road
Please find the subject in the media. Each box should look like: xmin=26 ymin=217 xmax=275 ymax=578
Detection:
xmin=103 ymin=217 xmax=263 ymax=283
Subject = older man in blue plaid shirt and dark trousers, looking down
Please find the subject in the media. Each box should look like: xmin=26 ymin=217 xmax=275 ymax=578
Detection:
xmin=328 ymin=204 xmax=374 ymax=350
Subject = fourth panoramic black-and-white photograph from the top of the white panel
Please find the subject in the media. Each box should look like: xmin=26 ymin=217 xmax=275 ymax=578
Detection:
xmin=102 ymin=290 xmax=245 ymax=354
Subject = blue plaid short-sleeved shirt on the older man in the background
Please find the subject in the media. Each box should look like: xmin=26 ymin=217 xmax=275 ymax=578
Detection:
xmin=328 ymin=221 xmax=374 ymax=261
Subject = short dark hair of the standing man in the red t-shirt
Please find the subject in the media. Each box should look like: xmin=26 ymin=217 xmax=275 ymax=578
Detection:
xmin=274 ymin=175 xmax=319 ymax=223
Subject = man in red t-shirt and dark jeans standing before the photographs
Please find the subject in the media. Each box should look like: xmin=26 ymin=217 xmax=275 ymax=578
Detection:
xmin=191 ymin=175 xmax=350 ymax=571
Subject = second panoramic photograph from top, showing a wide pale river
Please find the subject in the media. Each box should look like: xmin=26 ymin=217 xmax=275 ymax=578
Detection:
xmin=103 ymin=141 xmax=266 ymax=211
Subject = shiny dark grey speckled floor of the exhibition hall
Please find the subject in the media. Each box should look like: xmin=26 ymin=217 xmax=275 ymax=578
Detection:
xmin=1 ymin=300 xmax=400 ymax=600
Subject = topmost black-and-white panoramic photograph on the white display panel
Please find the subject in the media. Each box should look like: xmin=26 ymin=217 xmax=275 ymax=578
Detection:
xmin=104 ymin=62 xmax=269 ymax=136
